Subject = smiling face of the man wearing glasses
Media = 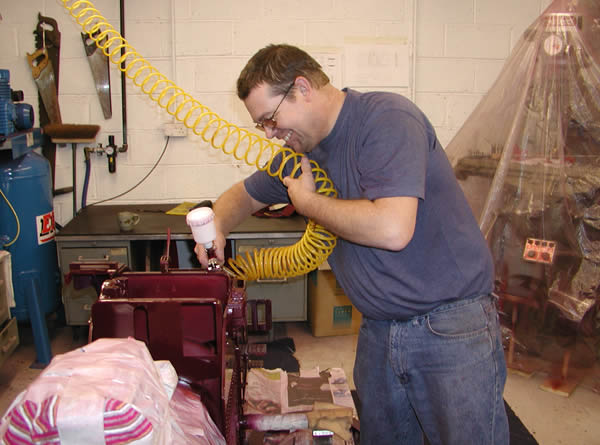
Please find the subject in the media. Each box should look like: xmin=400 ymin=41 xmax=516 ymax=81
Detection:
xmin=244 ymin=83 xmax=316 ymax=153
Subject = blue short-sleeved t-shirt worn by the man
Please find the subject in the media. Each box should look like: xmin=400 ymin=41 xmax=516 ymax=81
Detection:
xmin=244 ymin=90 xmax=493 ymax=320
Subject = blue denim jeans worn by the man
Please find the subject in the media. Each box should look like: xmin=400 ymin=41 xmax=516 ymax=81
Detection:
xmin=354 ymin=295 xmax=509 ymax=445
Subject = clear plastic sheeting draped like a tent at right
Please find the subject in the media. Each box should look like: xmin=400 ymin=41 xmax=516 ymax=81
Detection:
xmin=446 ymin=0 xmax=600 ymax=378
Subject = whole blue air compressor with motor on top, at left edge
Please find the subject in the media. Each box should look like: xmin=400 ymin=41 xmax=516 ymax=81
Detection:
xmin=0 ymin=70 xmax=60 ymax=321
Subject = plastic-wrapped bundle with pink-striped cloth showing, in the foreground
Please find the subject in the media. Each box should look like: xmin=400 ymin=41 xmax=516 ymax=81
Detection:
xmin=0 ymin=338 xmax=225 ymax=445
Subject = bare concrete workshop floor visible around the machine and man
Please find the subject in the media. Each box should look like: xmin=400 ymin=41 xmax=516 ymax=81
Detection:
xmin=0 ymin=322 xmax=600 ymax=445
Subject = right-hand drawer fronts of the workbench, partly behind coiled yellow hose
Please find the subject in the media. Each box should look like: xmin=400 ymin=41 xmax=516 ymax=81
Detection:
xmin=235 ymin=238 xmax=306 ymax=322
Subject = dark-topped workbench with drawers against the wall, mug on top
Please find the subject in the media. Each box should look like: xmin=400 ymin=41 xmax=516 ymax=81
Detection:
xmin=56 ymin=203 xmax=307 ymax=325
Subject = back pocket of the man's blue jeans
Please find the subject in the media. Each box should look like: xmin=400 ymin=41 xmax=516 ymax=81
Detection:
xmin=427 ymin=301 xmax=488 ymax=339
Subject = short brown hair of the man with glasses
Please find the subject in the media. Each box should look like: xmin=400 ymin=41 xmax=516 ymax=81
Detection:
xmin=237 ymin=44 xmax=329 ymax=100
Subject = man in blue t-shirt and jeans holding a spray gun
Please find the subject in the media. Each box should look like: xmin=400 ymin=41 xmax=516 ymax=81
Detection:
xmin=196 ymin=45 xmax=509 ymax=445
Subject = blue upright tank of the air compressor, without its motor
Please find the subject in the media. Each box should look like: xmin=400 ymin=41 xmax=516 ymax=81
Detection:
xmin=0 ymin=151 xmax=60 ymax=321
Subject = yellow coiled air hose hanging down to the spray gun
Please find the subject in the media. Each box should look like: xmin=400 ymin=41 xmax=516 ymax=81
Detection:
xmin=61 ymin=0 xmax=337 ymax=281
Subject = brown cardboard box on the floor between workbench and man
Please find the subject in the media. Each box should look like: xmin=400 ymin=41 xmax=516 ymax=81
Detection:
xmin=308 ymin=270 xmax=362 ymax=337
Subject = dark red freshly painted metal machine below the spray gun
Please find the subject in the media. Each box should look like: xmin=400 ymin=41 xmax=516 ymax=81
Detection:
xmin=88 ymin=254 xmax=247 ymax=444
